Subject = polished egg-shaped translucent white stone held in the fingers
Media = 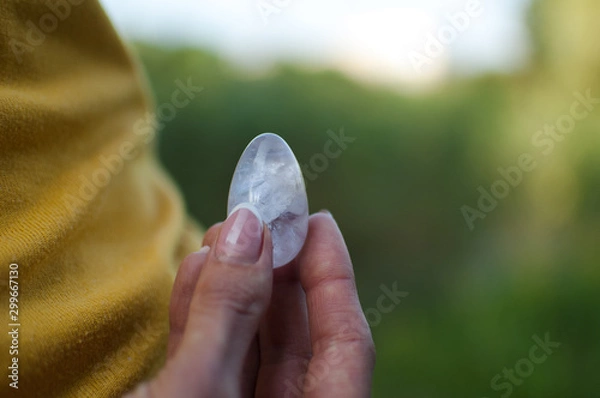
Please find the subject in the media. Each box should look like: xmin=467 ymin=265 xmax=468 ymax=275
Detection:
xmin=227 ymin=133 xmax=308 ymax=268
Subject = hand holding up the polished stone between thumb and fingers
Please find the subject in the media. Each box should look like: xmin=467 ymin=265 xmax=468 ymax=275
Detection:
xmin=128 ymin=208 xmax=375 ymax=398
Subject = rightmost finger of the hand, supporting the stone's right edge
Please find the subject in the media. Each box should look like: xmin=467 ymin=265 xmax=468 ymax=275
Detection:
xmin=298 ymin=213 xmax=375 ymax=397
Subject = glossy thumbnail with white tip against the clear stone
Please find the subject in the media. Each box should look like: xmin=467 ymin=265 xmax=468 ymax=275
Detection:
xmin=216 ymin=203 xmax=263 ymax=264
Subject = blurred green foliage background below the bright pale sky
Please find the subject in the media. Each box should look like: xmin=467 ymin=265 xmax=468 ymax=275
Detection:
xmin=136 ymin=0 xmax=600 ymax=398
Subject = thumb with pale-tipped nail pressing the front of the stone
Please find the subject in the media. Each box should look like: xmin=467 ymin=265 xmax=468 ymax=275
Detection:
xmin=142 ymin=205 xmax=273 ymax=397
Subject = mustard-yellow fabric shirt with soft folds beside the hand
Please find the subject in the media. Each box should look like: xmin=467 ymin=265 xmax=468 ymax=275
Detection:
xmin=0 ymin=0 xmax=201 ymax=397
